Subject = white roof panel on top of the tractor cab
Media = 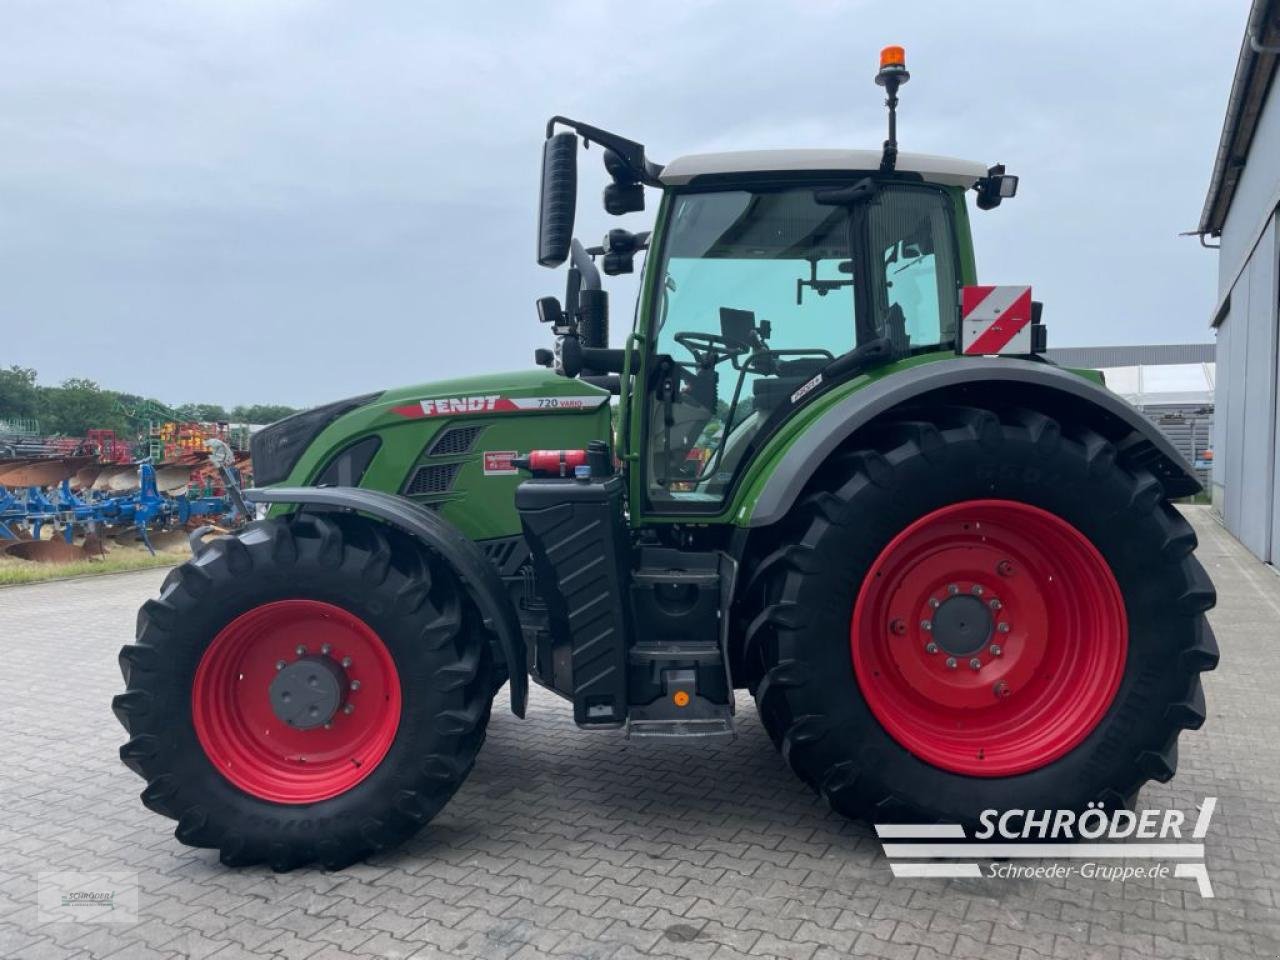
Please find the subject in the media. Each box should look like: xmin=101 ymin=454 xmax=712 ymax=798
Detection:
xmin=659 ymin=150 xmax=987 ymax=188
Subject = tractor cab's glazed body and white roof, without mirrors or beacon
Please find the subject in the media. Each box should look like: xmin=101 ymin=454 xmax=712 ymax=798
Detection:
xmin=640 ymin=151 xmax=986 ymax=509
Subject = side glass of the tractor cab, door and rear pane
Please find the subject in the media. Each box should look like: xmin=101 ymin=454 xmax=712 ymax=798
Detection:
xmin=648 ymin=186 xmax=957 ymax=507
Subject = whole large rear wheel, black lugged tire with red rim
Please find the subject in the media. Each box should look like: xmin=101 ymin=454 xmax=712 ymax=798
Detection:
xmin=744 ymin=406 xmax=1219 ymax=826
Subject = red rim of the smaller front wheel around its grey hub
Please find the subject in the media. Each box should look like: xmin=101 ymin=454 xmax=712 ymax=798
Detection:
xmin=191 ymin=600 xmax=401 ymax=804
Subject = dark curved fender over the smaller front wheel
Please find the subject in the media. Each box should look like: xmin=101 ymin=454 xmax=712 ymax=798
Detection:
xmin=244 ymin=486 xmax=529 ymax=717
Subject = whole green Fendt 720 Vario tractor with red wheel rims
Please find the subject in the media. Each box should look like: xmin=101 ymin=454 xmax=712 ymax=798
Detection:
xmin=114 ymin=47 xmax=1219 ymax=870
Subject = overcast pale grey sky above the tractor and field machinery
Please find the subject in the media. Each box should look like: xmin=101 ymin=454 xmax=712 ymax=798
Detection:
xmin=0 ymin=0 xmax=1248 ymax=404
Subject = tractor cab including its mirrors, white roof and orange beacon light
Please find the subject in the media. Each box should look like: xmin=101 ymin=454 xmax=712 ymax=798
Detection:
xmin=529 ymin=47 xmax=1016 ymax=516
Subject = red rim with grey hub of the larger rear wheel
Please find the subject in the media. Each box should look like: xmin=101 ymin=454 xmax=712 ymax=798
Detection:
xmin=851 ymin=500 xmax=1128 ymax=777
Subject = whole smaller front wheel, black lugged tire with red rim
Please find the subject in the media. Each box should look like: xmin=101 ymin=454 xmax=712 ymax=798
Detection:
xmin=113 ymin=513 xmax=492 ymax=870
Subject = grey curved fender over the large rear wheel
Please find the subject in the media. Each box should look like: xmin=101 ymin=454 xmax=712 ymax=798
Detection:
xmin=746 ymin=357 xmax=1201 ymax=527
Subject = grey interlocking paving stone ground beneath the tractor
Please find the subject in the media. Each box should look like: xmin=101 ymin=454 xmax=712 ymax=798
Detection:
xmin=0 ymin=508 xmax=1280 ymax=960
